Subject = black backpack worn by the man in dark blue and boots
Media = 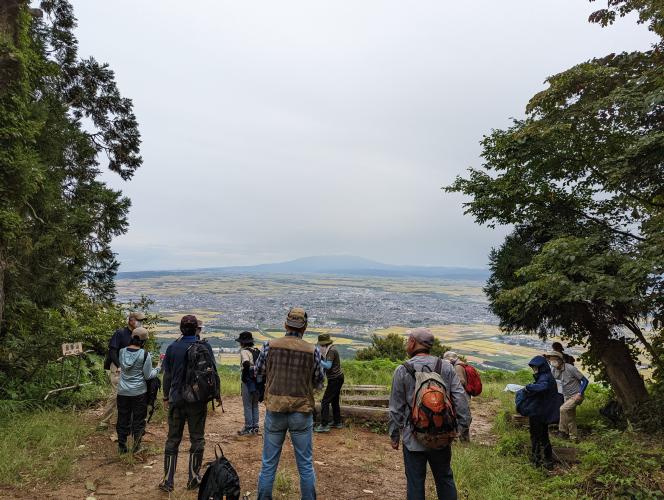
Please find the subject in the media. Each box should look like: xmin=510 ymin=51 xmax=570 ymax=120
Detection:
xmin=182 ymin=341 xmax=219 ymax=403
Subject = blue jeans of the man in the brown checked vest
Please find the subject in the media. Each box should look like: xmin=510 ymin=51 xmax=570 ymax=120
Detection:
xmin=258 ymin=411 xmax=316 ymax=500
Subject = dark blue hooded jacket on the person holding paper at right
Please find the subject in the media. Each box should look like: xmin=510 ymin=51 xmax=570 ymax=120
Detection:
xmin=518 ymin=356 xmax=560 ymax=424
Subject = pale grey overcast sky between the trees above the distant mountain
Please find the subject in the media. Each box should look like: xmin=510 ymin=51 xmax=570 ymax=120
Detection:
xmin=68 ymin=0 xmax=652 ymax=271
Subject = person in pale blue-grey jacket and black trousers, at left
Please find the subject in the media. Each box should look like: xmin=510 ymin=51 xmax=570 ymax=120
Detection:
xmin=116 ymin=327 xmax=161 ymax=454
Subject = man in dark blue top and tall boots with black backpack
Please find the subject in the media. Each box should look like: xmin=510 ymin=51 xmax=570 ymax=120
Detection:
xmin=159 ymin=314 xmax=221 ymax=492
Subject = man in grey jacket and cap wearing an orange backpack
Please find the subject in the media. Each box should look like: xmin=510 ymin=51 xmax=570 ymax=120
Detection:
xmin=389 ymin=328 xmax=469 ymax=500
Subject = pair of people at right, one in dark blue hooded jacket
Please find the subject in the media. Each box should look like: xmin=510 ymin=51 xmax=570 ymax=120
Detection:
xmin=517 ymin=342 xmax=589 ymax=469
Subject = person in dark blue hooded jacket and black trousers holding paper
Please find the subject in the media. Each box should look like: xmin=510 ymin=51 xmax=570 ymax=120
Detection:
xmin=520 ymin=356 xmax=559 ymax=470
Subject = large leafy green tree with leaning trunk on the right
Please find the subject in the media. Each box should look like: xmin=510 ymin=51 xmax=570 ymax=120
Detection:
xmin=446 ymin=0 xmax=664 ymax=407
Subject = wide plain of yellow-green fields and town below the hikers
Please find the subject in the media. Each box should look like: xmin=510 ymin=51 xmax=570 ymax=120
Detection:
xmin=117 ymin=271 xmax=572 ymax=370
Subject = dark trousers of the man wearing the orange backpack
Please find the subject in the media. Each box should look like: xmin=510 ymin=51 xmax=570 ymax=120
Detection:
xmin=403 ymin=446 xmax=457 ymax=500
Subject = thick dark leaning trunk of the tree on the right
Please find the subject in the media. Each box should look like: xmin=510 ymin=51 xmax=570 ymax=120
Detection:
xmin=590 ymin=332 xmax=649 ymax=411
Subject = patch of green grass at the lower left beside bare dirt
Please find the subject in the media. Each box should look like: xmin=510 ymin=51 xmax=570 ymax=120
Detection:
xmin=0 ymin=405 xmax=93 ymax=486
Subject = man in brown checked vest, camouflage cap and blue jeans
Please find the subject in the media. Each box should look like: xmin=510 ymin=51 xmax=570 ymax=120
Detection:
xmin=256 ymin=307 xmax=325 ymax=500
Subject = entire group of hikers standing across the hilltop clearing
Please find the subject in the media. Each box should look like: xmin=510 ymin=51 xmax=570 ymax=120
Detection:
xmin=100 ymin=307 xmax=588 ymax=500
